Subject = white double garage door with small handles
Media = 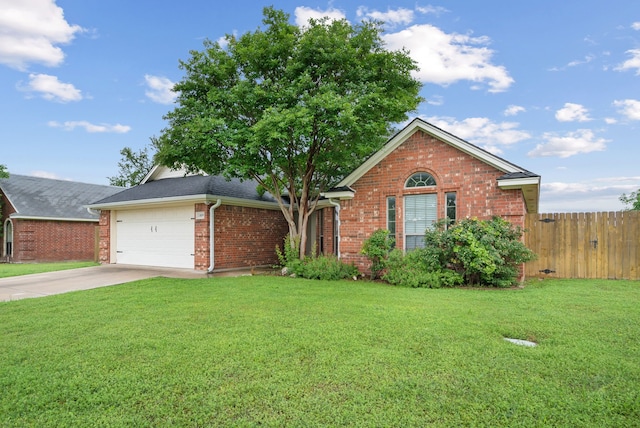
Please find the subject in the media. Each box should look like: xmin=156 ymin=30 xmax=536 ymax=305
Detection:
xmin=116 ymin=205 xmax=195 ymax=269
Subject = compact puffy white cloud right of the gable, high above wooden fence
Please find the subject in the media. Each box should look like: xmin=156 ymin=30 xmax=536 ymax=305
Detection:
xmin=528 ymin=129 xmax=610 ymax=158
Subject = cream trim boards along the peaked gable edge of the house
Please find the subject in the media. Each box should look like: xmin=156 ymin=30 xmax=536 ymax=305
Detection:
xmin=336 ymin=119 xmax=525 ymax=187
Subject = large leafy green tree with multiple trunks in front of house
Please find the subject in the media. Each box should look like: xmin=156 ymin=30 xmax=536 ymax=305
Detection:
xmin=157 ymin=8 xmax=422 ymax=255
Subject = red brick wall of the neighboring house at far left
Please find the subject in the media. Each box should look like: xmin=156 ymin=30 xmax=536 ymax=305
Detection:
xmin=11 ymin=219 xmax=97 ymax=263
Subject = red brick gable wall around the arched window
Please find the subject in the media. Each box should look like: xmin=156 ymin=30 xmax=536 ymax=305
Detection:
xmin=340 ymin=131 xmax=526 ymax=271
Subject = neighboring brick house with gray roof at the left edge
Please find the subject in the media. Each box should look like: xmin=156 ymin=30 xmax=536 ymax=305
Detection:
xmin=0 ymin=174 xmax=122 ymax=263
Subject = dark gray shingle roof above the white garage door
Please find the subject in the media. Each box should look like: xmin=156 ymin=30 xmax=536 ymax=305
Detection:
xmin=91 ymin=175 xmax=276 ymax=205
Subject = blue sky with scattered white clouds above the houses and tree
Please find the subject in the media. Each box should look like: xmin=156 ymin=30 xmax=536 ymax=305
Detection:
xmin=0 ymin=0 xmax=640 ymax=212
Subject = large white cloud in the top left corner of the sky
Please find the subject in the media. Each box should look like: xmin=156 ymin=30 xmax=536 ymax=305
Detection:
xmin=0 ymin=0 xmax=84 ymax=70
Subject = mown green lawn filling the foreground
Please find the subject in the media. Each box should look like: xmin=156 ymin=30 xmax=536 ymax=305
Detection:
xmin=0 ymin=277 xmax=640 ymax=427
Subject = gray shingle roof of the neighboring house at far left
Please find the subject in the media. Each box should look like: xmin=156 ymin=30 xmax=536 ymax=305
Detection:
xmin=0 ymin=174 xmax=123 ymax=220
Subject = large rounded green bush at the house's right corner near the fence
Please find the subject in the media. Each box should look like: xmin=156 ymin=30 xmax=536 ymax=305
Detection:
xmin=425 ymin=217 xmax=535 ymax=287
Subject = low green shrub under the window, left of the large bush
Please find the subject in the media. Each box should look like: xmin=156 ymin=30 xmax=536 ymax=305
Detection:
xmin=382 ymin=249 xmax=463 ymax=288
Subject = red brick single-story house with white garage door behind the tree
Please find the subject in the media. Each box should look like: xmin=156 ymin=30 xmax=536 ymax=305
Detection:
xmin=89 ymin=119 xmax=540 ymax=271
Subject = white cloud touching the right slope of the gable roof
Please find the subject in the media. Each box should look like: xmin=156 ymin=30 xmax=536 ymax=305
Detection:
xmin=425 ymin=117 xmax=531 ymax=154
